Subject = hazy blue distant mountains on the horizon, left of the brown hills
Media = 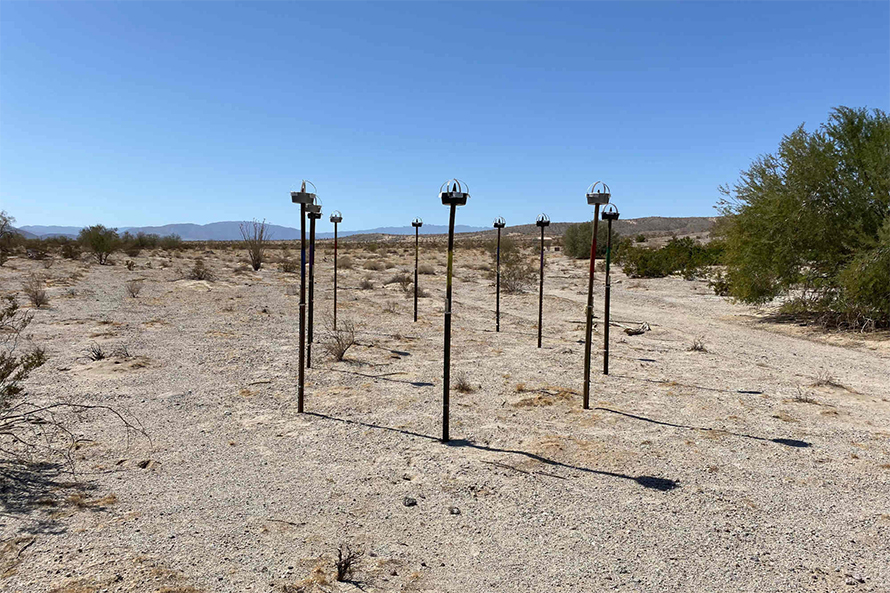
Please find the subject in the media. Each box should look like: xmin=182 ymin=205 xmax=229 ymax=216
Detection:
xmin=18 ymin=220 xmax=485 ymax=241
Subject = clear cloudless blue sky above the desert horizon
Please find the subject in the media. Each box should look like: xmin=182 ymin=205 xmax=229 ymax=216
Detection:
xmin=0 ymin=1 xmax=890 ymax=230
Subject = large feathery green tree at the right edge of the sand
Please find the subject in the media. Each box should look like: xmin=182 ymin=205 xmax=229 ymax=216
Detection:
xmin=720 ymin=107 xmax=890 ymax=326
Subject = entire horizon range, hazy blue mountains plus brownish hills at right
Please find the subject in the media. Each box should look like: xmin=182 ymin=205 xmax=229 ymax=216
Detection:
xmin=18 ymin=216 xmax=716 ymax=241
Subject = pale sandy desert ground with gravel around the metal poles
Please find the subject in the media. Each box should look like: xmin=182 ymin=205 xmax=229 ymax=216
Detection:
xmin=0 ymin=242 xmax=890 ymax=593
